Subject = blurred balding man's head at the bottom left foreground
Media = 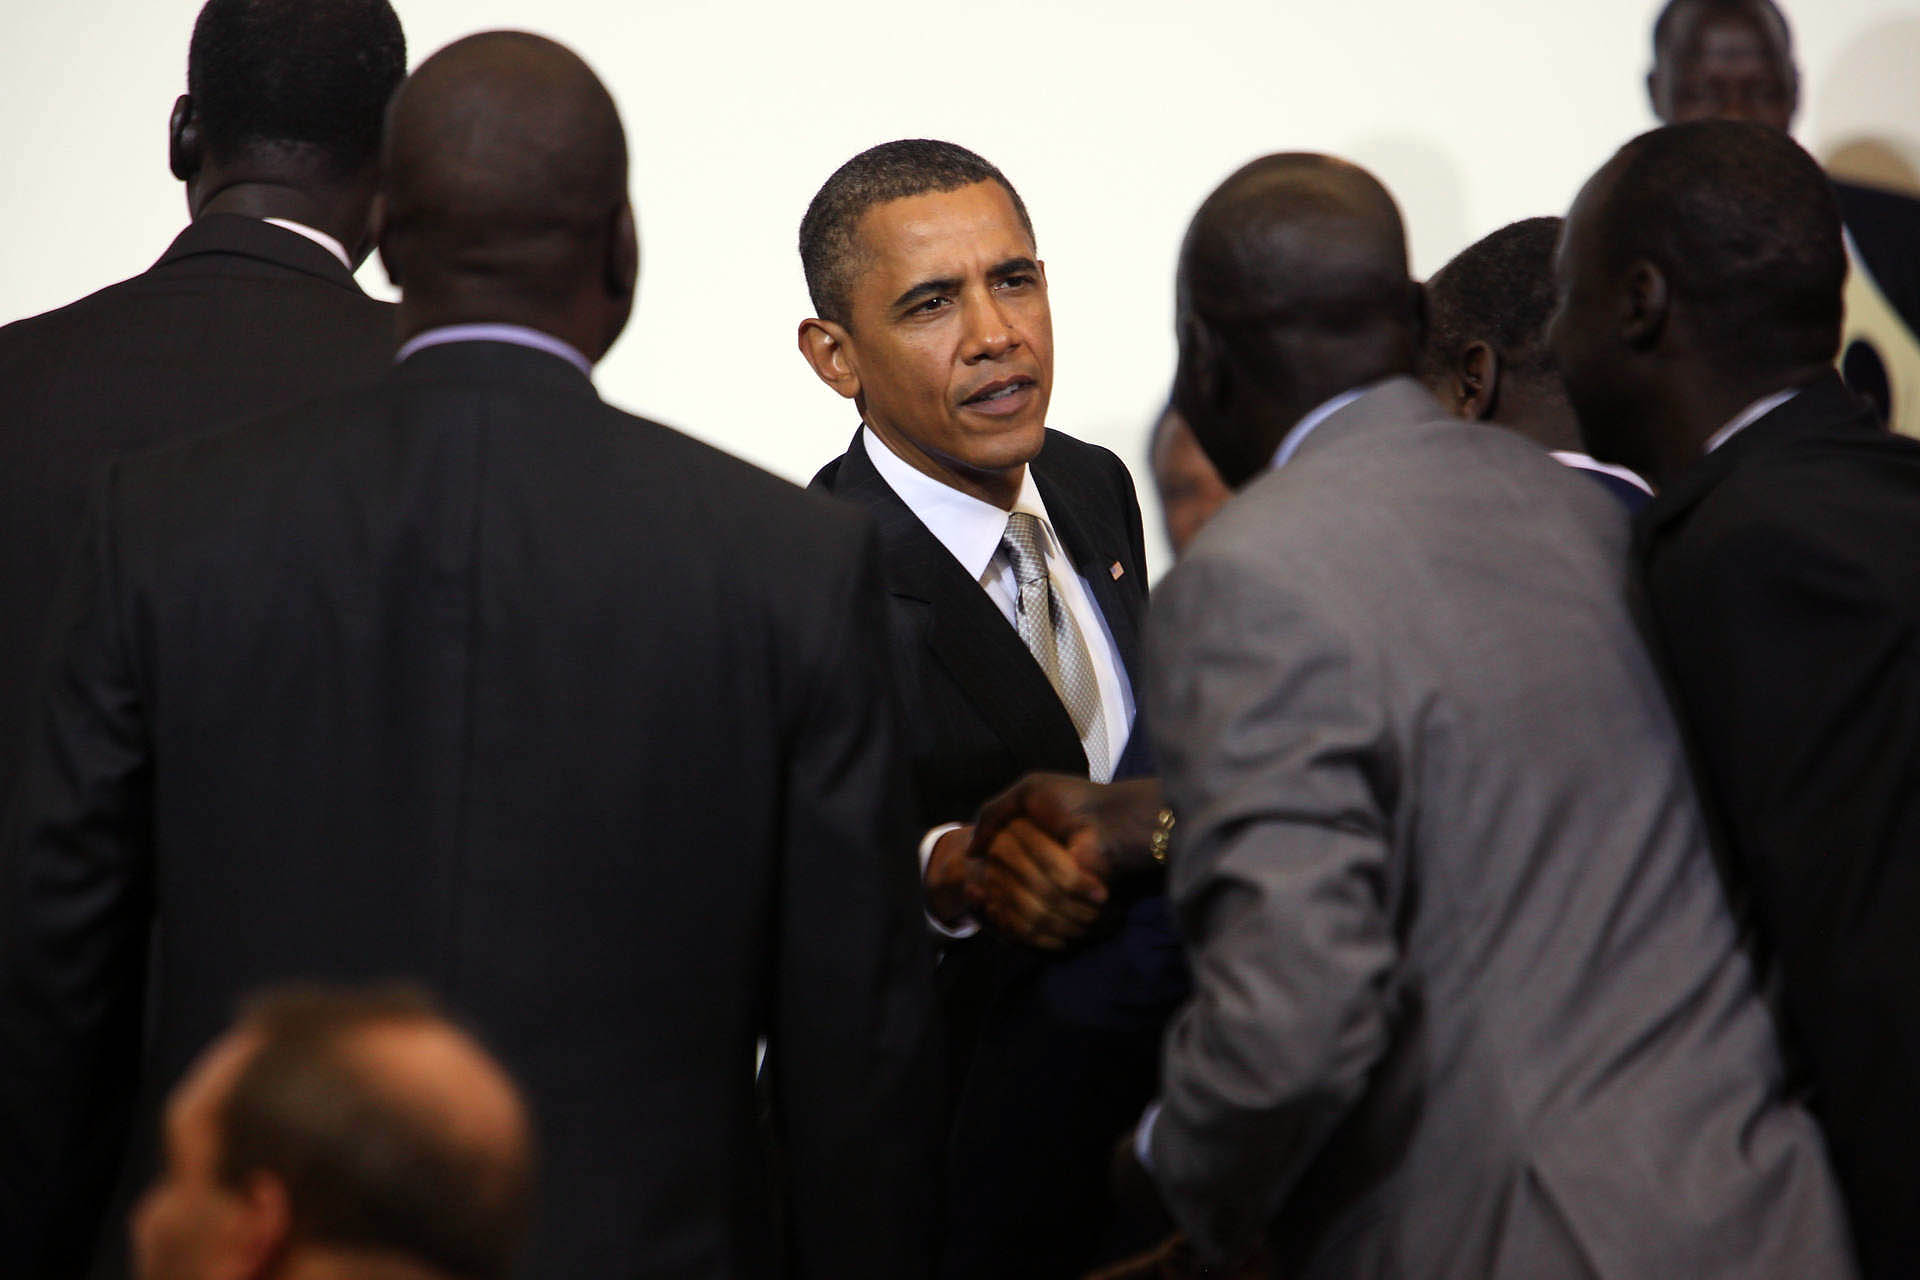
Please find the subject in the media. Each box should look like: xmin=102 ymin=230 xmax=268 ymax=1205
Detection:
xmin=132 ymin=988 xmax=534 ymax=1280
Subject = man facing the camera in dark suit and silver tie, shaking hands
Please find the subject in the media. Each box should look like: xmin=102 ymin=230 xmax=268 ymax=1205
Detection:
xmin=799 ymin=140 xmax=1179 ymax=1276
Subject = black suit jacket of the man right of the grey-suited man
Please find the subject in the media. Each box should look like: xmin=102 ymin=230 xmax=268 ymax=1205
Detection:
xmin=1636 ymin=376 xmax=1920 ymax=1276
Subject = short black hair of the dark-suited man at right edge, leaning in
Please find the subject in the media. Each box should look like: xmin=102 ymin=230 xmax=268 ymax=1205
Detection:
xmin=1597 ymin=119 xmax=1847 ymax=368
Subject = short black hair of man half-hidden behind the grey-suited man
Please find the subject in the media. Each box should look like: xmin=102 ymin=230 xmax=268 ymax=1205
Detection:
xmin=1421 ymin=217 xmax=1561 ymax=382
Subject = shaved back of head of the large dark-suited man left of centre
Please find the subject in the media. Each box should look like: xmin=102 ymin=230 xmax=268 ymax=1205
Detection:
xmin=380 ymin=31 xmax=637 ymax=359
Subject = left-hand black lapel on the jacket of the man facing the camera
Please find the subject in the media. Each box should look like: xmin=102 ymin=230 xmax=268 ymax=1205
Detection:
xmin=822 ymin=436 xmax=1087 ymax=771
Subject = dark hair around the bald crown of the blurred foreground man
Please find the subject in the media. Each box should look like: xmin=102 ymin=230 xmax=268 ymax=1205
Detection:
xmin=217 ymin=986 xmax=532 ymax=1280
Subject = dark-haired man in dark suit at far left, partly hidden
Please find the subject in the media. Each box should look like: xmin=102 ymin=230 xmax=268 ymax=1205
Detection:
xmin=0 ymin=0 xmax=407 ymax=804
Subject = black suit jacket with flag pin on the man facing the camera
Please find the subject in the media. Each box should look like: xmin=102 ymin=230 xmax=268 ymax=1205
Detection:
xmin=814 ymin=432 xmax=1159 ymax=1278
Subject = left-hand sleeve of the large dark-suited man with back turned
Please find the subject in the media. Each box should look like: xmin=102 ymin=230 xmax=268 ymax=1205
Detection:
xmin=0 ymin=472 xmax=152 ymax=1276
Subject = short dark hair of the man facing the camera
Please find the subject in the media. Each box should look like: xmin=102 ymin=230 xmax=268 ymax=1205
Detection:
xmin=801 ymin=138 xmax=1033 ymax=324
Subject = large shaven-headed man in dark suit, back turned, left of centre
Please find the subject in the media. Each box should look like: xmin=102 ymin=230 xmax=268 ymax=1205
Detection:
xmin=0 ymin=33 xmax=931 ymax=1278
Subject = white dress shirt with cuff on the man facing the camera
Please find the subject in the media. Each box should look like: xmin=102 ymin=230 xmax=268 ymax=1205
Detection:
xmin=860 ymin=428 xmax=1135 ymax=938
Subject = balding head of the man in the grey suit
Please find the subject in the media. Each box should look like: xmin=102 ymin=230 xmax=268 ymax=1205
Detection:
xmin=1175 ymin=154 xmax=1421 ymax=487
